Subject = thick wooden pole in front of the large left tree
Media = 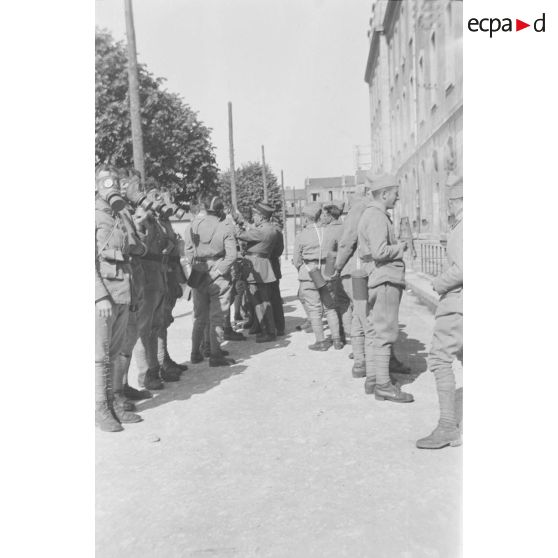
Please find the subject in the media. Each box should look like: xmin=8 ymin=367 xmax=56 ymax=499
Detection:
xmin=124 ymin=0 xmax=145 ymax=184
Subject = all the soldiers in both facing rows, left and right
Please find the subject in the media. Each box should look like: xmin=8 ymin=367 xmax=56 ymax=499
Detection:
xmin=95 ymin=166 xmax=463 ymax=449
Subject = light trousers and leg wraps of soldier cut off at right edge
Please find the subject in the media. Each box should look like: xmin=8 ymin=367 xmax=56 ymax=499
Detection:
xmin=428 ymin=299 xmax=463 ymax=428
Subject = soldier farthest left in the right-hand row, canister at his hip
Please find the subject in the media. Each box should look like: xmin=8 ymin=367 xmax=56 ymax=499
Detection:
xmin=293 ymin=203 xmax=343 ymax=351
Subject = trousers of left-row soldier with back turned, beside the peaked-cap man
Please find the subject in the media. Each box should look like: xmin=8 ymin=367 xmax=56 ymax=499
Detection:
xmin=192 ymin=276 xmax=232 ymax=356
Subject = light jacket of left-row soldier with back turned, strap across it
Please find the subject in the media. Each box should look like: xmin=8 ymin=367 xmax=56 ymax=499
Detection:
xmin=184 ymin=215 xmax=237 ymax=275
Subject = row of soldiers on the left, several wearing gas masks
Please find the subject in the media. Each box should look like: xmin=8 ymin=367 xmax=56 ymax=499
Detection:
xmin=95 ymin=165 xmax=285 ymax=432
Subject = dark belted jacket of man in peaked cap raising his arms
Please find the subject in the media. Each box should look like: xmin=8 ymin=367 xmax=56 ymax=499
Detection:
xmin=238 ymin=221 xmax=279 ymax=283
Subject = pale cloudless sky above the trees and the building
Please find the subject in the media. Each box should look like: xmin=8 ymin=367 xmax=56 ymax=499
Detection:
xmin=95 ymin=0 xmax=372 ymax=188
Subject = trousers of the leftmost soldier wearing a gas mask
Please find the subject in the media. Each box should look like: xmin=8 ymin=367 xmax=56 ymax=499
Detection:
xmin=95 ymin=303 xmax=129 ymax=403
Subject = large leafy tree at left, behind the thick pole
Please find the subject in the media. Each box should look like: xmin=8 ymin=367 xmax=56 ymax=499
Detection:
xmin=95 ymin=29 xmax=219 ymax=200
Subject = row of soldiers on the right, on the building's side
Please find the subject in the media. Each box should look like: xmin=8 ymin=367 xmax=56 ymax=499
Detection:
xmin=293 ymin=174 xmax=463 ymax=449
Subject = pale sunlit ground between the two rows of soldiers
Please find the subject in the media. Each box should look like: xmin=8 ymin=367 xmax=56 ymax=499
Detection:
xmin=96 ymin=264 xmax=462 ymax=558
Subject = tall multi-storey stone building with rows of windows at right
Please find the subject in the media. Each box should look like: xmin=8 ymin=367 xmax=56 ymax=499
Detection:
xmin=365 ymin=0 xmax=463 ymax=272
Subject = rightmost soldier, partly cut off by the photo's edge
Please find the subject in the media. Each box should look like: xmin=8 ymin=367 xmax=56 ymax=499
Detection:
xmin=417 ymin=174 xmax=463 ymax=449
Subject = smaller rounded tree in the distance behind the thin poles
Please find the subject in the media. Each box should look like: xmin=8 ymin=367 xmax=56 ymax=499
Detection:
xmin=219 ymin=163 xmax=283 ymax=225
